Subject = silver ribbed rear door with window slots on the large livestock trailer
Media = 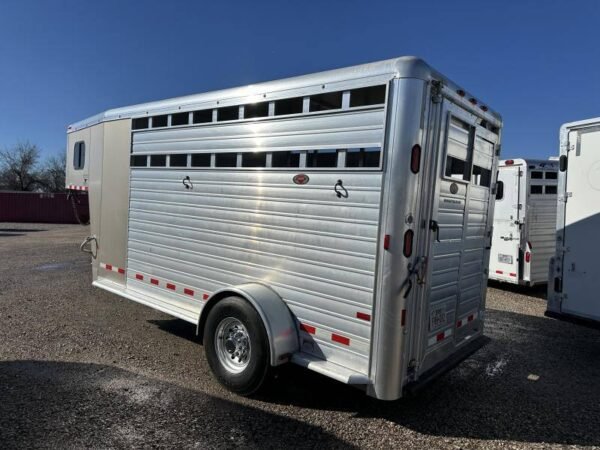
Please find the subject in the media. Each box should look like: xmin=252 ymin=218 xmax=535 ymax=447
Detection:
xmin=420 ymin=99 xmax=499 ymax=372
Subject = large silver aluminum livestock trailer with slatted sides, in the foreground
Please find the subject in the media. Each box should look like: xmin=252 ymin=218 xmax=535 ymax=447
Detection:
xmin=67 ymin=57 xmax=501 ymax=400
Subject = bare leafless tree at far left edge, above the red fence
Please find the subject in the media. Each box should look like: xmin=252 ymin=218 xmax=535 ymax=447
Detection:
xmin=0 ymin=142 xmax=42 ymax=191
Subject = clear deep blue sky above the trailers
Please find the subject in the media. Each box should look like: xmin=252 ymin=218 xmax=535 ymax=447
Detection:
xmin=0 ymin=0 xmax=600 ymax=157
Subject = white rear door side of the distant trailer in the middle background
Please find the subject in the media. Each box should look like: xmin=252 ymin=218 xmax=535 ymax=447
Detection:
xmin=490 ymin=165 xmax=524 ymax=283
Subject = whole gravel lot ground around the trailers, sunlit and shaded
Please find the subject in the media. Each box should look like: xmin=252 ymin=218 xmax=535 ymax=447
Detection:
xmin=0 ymin=224 xmax=600 ymax=448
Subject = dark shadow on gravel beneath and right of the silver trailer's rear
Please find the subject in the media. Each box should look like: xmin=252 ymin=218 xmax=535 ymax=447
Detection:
xmin=254 ymin=310 xmax=600 ymax=445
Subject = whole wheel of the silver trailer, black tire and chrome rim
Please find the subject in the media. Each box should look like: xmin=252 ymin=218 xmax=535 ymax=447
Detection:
xmin=203 ymin=297 xmax=270 ymax=395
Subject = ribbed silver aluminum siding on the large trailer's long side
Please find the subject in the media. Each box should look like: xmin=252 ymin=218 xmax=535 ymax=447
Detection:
xmin=128 ymin=110 xmax=384 ymax=373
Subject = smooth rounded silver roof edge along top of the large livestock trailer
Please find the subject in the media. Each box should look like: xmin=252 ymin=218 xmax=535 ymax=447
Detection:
xmin=68 ymin=56 xmax=502 ymax=132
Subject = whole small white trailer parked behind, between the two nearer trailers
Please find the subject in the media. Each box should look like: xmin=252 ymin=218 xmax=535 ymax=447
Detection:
xmin=490 ymin=159 xmax=558 ymax=286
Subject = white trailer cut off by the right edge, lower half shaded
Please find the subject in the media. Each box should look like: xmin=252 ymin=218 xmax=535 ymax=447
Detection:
xmin=546 ymin=118 xmax=600 ymax=324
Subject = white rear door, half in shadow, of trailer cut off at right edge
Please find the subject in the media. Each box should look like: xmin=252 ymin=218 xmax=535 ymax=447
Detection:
xmin=561 ymin=127 xmax=600 ymax=320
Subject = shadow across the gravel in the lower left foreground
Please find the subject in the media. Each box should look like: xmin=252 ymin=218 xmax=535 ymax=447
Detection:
xmin=0 ymin=361 xmax=349 ymax=448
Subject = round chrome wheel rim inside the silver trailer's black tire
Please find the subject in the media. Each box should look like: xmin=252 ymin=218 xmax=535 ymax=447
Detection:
xmin=215 ymin=317 xmax=251 ymax=373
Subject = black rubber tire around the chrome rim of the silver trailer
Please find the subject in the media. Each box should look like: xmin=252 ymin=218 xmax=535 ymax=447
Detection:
xmin=203 ymin=297 xmax=270 ymax=396
